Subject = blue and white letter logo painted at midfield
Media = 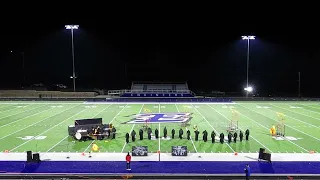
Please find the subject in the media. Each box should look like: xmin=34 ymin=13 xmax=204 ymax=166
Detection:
xmin=124 ymin=113 xmax=192 ymax=124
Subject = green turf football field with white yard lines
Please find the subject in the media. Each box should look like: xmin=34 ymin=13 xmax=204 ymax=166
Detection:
xmin=0 ymin=101 xmax=320 ymax=153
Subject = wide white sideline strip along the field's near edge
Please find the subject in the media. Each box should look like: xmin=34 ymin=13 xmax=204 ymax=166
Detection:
xmin=0 ymin=152 xmax=320 ymax=162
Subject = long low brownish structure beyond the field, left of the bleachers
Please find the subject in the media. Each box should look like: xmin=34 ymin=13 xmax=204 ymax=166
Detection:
xmin=0 ymin=90 xmax=97 ymax=98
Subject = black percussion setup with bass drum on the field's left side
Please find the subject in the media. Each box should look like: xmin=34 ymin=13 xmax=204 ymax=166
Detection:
xmin=68 ymin=118 xmax=115 ymax=141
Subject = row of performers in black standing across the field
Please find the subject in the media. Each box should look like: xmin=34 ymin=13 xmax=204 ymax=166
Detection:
xmin=125 ymin=127 xmax=250 ymax=143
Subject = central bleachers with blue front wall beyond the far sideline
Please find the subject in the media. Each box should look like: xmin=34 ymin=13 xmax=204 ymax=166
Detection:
xmin=119 ymin=82 xmax=195 ymax=98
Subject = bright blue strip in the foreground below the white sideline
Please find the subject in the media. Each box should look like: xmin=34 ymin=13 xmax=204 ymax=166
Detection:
xmin=0 ymin=161 xmax=320 ymax=175
